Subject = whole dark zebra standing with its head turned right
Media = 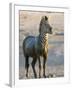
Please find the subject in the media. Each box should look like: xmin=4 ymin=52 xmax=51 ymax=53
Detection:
xmin=23 ymin=16 xmax=52 ymax=78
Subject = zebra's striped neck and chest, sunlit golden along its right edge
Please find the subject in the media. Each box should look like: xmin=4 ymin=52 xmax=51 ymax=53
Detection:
xmin=39 ymin=33 xmax=48 ymax=48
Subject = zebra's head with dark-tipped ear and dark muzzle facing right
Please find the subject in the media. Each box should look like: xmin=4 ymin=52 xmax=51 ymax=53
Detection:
xmin=39 ymin=16 xmax=52 ymax=34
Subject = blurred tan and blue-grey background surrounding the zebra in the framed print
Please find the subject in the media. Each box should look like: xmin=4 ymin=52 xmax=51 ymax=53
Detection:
xmin=19 ymin=11 xmax=64 ymax=79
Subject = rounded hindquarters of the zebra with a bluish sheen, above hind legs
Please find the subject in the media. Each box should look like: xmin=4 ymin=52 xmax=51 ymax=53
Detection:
xmin=23 ymin=36 xmax=36 ymax=57
